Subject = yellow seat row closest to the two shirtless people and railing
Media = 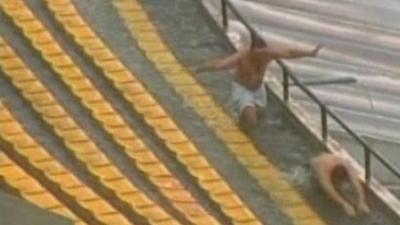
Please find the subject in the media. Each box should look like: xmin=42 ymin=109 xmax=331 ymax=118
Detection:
xmin=115 ymin=0 xmax=325 ymax=224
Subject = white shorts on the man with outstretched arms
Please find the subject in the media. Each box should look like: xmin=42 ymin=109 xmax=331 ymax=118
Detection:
xmin=232 ymin=82 xmax=267 ymax=118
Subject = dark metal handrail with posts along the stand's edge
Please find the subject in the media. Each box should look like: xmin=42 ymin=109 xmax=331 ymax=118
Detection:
xmin=221 ymin=0 xmax=400 ymax=184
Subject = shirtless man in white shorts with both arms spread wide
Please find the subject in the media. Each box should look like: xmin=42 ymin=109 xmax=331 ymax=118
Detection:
xmin=194 ymin=41 xmax=321 ymax=128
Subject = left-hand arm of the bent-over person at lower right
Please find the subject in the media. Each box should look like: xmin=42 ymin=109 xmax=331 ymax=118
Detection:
xmin=311 ymin=158 xmax=355 ymax=216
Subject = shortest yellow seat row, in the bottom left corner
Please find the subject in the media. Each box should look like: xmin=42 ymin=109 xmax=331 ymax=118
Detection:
xmin=0 ymin=152 xmax=82 ymax=225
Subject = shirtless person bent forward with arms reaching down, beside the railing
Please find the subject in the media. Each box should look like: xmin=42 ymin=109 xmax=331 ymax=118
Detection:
xmin=311 ymin=153 xmax=369 ymax=216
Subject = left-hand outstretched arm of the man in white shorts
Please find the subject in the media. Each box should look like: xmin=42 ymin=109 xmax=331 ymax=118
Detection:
xmin=193 ymin=49 xmax=246 ymax=73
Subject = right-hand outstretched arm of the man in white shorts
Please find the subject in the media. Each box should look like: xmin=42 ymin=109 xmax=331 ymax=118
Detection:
xmin=266 ymin=45 xmax=323 ymax=59
